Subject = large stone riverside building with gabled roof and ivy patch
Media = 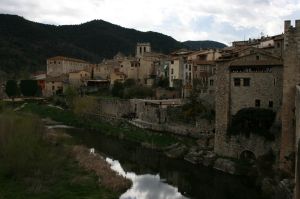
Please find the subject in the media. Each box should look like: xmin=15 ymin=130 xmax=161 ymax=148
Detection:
xmin=214 ymin=47 xmax=283 ymax=158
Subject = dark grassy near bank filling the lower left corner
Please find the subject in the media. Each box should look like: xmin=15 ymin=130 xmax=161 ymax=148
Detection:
xmin=0 ymin=112 xmax=126 ymax=199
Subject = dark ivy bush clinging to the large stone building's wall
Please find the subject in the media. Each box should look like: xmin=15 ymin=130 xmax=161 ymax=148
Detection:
xmin=228 ymin=108 xmax=276 ymax=140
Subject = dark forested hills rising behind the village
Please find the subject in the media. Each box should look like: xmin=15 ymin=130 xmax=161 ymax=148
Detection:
xmin=0 ymin=14 xmax=225 ymax=76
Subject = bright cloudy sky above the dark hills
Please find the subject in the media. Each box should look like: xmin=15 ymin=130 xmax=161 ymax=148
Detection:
xmin=0 ymin=0 xmax=300 ymax=44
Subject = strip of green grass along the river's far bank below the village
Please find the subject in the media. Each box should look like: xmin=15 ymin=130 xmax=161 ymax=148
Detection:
xmin=23 ymin=103 xmax=194 ymax=148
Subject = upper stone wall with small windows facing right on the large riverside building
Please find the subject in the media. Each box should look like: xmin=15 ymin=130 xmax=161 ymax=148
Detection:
xmin=230 ymin=66 xmax=282 ymax=115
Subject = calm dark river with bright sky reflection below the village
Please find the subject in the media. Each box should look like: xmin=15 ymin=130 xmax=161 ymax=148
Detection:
xmin=66 ymin=129 xmax=259 ymax=199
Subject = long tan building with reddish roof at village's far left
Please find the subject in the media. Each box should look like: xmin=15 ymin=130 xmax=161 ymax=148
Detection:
xmin=47 ymin=56 xmax=90 ymax=76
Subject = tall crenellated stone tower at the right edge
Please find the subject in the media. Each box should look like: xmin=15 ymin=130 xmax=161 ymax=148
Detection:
xmin=279 ymin=20 xmax=300 ymax=173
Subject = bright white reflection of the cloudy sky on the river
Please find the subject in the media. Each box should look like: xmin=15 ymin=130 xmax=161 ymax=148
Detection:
xmin=106 ymin=158 xmax=186 ymax=199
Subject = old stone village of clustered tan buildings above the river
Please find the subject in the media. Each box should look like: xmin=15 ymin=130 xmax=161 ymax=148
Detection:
xmin=0 ymin=20 xmax=300 ymax=198
